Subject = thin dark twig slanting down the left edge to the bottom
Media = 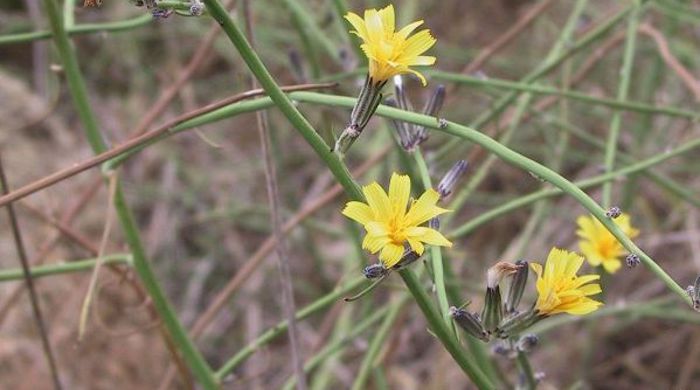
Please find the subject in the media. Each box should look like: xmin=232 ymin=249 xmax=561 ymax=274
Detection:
xmin=0 ymin=154 xmax=62 ymax=389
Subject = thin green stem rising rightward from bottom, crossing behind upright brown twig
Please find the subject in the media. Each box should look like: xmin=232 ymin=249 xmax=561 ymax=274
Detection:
xmin=214 ymin=277 xmax=367 ymax=381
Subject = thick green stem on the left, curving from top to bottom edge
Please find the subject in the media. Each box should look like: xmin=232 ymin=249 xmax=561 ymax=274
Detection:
xmin=43 ymin=0 xmax=218 ymax=389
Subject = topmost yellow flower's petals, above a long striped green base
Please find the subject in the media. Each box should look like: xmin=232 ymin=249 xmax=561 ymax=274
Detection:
xmin=345 ymin=5 xmax=436 ymax=85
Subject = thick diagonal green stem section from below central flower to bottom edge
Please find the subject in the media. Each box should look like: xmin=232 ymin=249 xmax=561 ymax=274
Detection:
xmin=399 ymin=268 xmax=494 ymax=389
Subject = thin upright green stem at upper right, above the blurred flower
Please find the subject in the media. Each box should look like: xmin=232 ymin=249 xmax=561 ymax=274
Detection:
xmin=601 ymin=0 xmax=641 ymax=208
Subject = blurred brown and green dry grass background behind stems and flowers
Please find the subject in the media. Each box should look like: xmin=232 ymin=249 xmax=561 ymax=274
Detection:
xmin=0 ymin=0 xmax=700 ymax=389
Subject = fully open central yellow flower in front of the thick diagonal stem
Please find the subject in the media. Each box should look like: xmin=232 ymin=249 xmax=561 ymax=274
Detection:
xmin=343 ymin=173 xmax=452 ymax=268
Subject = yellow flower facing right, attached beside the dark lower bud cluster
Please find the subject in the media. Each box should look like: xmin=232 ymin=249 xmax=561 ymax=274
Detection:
xmin=530 ymin=248 xmax=602 ymax=316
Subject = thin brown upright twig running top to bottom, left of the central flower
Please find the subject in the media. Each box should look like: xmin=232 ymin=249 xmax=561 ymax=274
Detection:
xmin=243 ymin=0 xmax=307 ymax=390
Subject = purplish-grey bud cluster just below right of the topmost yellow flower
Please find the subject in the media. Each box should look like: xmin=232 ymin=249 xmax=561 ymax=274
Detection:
xmin=387 ymin=76 xmax=445 ymax=152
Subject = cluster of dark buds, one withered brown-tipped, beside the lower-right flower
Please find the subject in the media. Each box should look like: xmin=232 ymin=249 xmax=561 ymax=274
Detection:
xmin=449 ymin=260 xmax=539 ymax=342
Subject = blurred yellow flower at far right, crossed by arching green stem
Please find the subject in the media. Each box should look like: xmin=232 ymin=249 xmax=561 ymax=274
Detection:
xmin=576 ymin=213 xmax=639 ymax=273
